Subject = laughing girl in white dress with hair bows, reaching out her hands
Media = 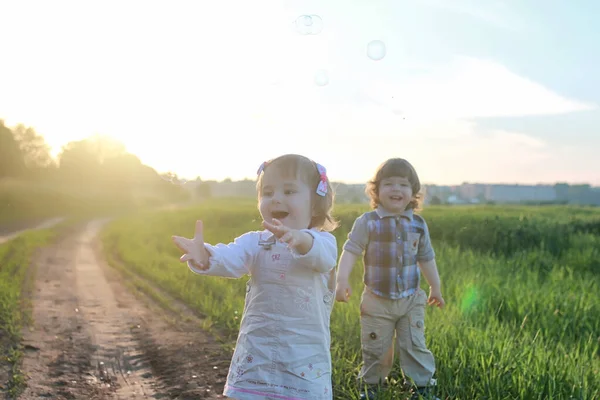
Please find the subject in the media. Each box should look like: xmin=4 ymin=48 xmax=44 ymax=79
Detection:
xmin=173 ymin=154 xmax=337 ymax=400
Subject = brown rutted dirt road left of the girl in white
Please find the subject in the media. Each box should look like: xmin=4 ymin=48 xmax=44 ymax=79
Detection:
xmin=19 ymin=220 xmax=230 ymax=400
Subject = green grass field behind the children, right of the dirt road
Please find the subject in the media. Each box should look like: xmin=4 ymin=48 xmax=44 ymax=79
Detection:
xmin=103 ymin=200 xmax=600 ymax=399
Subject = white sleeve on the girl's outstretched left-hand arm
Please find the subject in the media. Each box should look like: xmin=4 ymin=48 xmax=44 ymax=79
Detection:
xmin=187 ymin=232 xmax=258 ymax=278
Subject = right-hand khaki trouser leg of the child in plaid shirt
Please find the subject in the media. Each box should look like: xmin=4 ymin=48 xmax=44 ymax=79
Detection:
xmin=396 ymin=289 xmax=435 ymax=387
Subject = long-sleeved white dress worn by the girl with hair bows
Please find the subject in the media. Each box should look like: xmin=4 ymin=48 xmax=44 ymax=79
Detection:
xmin=188 ymin=229 xmax=337 ymax=400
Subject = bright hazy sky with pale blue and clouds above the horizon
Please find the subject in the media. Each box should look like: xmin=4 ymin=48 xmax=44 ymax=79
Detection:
xmin=0 ymin=0 xmax=600 ymax=185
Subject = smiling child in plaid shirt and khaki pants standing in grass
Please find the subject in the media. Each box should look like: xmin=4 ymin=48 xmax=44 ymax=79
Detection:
xmin=336 ymin=158 xmax=444 ymax=399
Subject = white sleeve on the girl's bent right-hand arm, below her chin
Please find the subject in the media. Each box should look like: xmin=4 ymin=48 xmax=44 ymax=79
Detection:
xmin=292 ymin=229 xmax=337 ymax=273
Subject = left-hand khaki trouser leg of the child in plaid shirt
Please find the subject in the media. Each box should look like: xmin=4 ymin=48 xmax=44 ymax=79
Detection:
xmin=358 ymin=288 xmax=396 ymax=385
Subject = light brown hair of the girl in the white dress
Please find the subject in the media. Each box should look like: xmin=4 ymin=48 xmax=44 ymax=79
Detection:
xmin=256 ymin=154 xmax=338 ymax=232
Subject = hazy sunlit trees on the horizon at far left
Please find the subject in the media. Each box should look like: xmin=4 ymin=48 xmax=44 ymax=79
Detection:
xmin=0 ymin=120 xmax=188 ymax=206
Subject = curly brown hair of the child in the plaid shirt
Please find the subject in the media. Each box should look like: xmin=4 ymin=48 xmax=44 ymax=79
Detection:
xmin=365 ymin=158 xmax=422 ymax=211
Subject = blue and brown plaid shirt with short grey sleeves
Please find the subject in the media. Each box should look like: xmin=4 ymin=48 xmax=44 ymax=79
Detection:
xmin=344 ymin=208 xmax=435 ymax=299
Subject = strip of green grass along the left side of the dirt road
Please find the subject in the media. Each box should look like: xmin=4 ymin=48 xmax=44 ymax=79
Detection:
xmin=0 ymin=229 xmax=55 ymax=397
